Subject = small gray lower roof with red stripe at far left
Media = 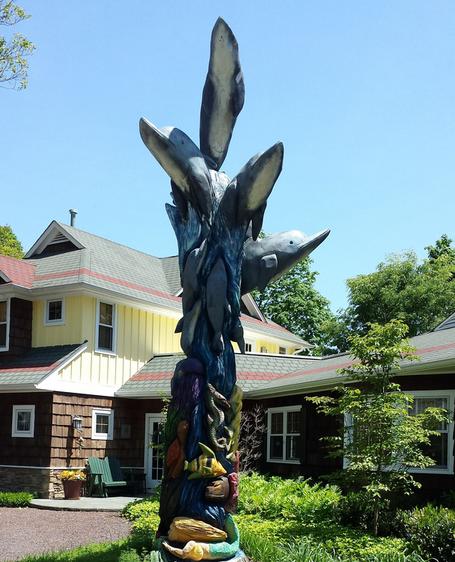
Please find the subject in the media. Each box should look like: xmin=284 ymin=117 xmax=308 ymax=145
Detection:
xmin=0 ymin=343 xmax=85 ymax=389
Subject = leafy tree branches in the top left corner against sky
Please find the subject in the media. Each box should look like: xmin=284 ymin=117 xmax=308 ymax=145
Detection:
xmin=0 ymin=0 xmax=35 ymax=90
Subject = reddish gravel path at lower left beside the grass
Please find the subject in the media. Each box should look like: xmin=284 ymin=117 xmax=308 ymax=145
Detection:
xmin=0 ymin=507 xmax=130 ymax=562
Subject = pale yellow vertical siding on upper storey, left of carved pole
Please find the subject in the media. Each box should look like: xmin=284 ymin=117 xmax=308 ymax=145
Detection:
xmin=33 ymin=296 xmax=181 ymax=386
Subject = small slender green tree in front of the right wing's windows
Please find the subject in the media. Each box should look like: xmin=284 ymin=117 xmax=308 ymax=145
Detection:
xmin=307 ymin=320 xmax=447 ymax=534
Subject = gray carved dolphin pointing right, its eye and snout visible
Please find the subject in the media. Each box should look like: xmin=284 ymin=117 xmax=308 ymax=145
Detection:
xmin=241 ymin=230 xmax=330 ymax=295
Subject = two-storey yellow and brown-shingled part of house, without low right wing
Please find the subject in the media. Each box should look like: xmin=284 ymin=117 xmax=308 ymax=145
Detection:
xmin=0 ymin=221 xmax=310 ymax=496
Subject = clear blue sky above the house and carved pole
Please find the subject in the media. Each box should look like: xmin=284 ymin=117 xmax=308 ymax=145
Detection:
xmin=0 ymin=0 xmax=455 ymax=310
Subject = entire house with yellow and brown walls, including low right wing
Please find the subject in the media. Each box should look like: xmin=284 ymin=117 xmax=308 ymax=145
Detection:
xmin=0 ymin=221 xmax=455 ymax=497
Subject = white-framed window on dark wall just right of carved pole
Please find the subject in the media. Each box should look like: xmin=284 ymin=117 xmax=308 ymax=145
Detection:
xmin=267 ymin=406 xmax=302 ymax=464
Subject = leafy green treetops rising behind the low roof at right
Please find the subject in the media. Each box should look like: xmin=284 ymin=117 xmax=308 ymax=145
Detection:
xmin=325 ymin=235 xmax=455 ymax=351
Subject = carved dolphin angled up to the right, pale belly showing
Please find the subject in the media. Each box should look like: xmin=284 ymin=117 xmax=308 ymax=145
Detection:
xmin=237 ymin=142 xmax=284 ymax=240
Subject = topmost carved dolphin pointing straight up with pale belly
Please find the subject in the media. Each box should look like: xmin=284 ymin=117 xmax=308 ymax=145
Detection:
xmin=200 ymin=18 xmax=245 ymax=170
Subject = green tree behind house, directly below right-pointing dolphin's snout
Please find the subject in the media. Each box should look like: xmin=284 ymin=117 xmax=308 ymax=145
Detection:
xmin=253 ymin=258 xmax=332 ymax=353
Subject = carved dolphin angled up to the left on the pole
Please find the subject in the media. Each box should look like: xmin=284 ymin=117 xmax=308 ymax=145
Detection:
xmin=139 ymin=118 xmax=214 ymax=222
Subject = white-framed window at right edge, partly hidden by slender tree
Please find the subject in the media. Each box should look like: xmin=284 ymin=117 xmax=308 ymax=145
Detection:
xmin=411 ymin=390 xmax=454 ymax=474
